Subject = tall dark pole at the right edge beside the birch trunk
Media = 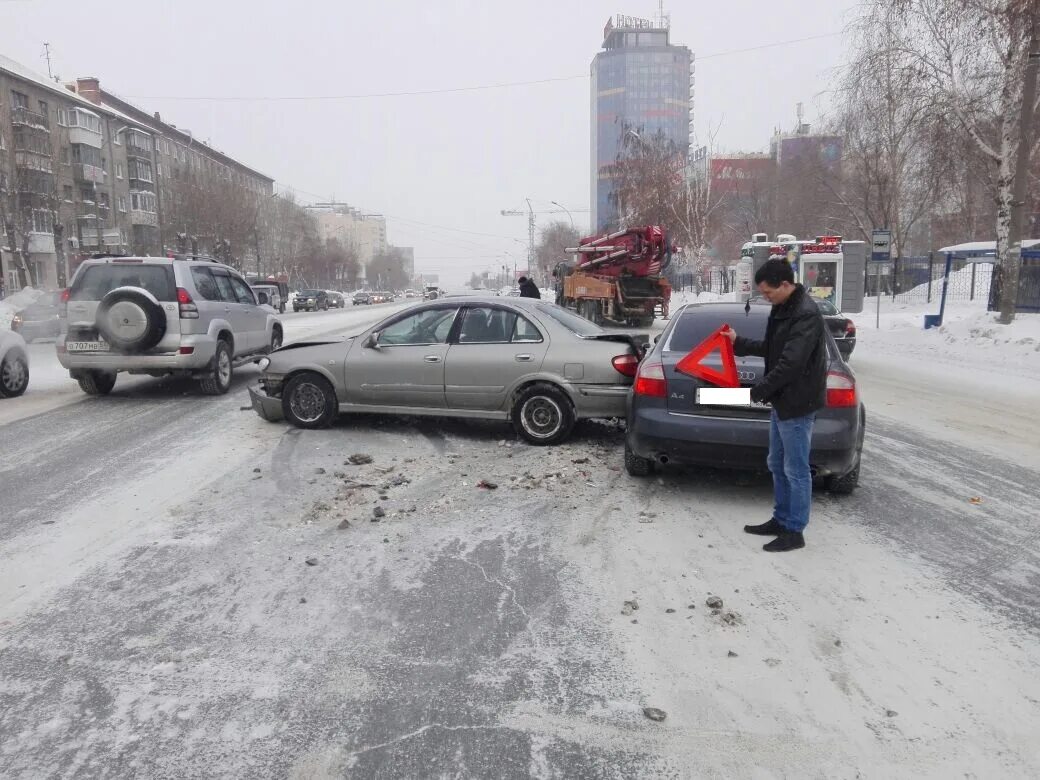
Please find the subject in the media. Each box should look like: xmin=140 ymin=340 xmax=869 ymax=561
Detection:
xmin=999 ymin=5 xmax=1040 ymax=324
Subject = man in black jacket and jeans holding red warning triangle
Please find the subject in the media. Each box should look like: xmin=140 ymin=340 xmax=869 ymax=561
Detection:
xmin=727 ymin=260 xmax=827 ymax=552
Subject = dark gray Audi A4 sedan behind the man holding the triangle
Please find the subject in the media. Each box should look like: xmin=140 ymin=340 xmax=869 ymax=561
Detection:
xmin=625 ymin=304 xmax=866 ymax=493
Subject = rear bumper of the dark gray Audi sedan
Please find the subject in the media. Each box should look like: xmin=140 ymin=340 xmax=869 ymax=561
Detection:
xmin=626 ymin=409 xmax=859 ymax=476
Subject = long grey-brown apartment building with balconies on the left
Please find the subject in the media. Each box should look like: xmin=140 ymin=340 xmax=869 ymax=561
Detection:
xmin=0 ymin=55 xmax=275 ymax=292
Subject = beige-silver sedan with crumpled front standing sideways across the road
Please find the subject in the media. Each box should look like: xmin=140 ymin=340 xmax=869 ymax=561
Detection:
xmin=250 ymin=296 xmax=646 ymax=445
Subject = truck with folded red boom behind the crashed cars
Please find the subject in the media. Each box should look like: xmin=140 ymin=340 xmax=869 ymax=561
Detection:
xmin=553 ymin=225 xmax=672 ymax=328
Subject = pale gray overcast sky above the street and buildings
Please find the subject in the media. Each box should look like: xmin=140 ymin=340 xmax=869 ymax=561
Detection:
xmin=0 ymin=0 xmax=855 ymax=281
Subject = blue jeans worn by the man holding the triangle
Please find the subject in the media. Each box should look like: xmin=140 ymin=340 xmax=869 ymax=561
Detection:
xmin=765 ymin=412 xmax=816 ymax=531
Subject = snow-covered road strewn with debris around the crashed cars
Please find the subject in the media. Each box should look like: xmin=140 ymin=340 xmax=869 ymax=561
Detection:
xmin=0 ymin=309 xmax=1040 ymax=778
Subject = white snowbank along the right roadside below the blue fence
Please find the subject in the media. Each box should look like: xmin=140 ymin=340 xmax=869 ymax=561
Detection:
xmin=853 ymin=295 xmax=1040 ymax=378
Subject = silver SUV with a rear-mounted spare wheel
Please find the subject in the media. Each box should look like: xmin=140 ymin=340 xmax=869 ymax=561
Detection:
xmin=57 ymin=257 xmax=283 ymax=395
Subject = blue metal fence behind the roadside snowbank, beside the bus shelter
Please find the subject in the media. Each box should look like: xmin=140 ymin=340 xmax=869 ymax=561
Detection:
xmin=864 ymin=253 xmax=993 ymax=303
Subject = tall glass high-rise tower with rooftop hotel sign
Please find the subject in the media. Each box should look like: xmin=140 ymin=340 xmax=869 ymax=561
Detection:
xmin=592 ymin=15 xmax=694 ymax=230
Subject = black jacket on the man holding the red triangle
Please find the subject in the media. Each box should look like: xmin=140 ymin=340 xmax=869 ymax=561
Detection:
xmin=733 ymin=284 xmax=827 ymax=420
